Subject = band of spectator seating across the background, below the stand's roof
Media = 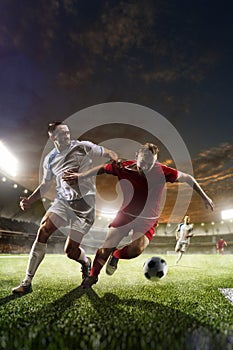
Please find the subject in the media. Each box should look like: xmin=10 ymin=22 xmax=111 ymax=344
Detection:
xmin=0 ymin=217 xmax=233 ymax=254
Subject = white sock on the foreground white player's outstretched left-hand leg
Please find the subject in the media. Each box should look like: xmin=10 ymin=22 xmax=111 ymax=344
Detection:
xmin=24 ymin=241 xmax=47 ymax=283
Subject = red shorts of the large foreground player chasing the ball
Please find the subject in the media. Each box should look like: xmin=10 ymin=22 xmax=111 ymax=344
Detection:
xmin=109 ymin=211 xmax=158 ymax=241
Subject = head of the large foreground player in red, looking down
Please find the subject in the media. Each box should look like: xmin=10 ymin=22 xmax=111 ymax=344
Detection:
xmin=136 ymin=142 xmax=159 ymax=172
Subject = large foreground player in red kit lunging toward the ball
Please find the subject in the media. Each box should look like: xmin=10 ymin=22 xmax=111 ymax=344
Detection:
xmin=63 ymin=143 xmax=214 ymax=288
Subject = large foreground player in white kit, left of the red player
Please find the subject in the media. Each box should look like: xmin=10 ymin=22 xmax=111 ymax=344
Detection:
xmin=12 ymin=122 xmax=118 ymax=294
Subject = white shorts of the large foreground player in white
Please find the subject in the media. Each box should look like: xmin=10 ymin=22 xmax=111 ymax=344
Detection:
xmin=47 ymin=196 xmax=95 ymax=235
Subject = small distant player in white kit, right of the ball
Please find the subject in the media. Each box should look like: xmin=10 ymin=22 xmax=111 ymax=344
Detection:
xmin=175 ymin=215 xmax=193 ymax=265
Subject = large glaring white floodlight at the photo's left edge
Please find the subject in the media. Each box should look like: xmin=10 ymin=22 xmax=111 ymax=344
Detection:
xmin=0 ymin=141 xmax=18 ymax=176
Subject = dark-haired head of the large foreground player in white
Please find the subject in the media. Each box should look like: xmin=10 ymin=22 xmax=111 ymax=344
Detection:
xmin=48 ymin=121 xmax=70 ymax=148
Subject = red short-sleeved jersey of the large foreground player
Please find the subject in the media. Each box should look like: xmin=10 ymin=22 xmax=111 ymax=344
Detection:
xmin=105 ymin=160 xmax=178 ymax=220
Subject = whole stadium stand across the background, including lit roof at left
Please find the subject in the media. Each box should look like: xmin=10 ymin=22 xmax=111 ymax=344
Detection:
xmin=0 ymin=174 xmax=233 ymax=254
